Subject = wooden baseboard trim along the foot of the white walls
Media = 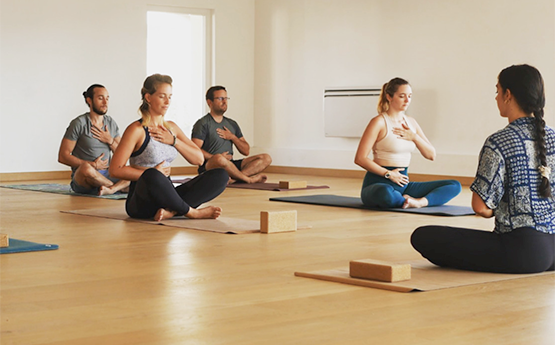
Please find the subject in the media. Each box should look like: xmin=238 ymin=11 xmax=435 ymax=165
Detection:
xmin=0 ymin=165 xmax=474 ymax=186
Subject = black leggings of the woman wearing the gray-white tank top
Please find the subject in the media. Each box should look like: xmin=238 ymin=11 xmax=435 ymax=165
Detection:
xmin=125 ymin=168 xmax=229 ymax=219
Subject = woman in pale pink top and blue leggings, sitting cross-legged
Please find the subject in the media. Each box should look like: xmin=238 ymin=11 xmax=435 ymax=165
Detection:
xmin=355 ymin=78 xmax=461 ymax=208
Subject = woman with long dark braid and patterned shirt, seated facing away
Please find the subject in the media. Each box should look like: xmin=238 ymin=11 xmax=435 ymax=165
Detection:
xmin=411 ymin=65 xmax=555 ymax=273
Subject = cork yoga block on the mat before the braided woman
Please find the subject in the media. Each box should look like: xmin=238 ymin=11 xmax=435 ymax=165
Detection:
xmin=349 ymin=259 xmax=411 ymax=282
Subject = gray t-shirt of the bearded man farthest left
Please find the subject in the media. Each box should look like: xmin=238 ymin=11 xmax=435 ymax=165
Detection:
xmin=64 ymin=113 xmax=119 ymax=171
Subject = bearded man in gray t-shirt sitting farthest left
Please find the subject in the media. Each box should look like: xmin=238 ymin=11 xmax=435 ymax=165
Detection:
xmin=58 ymin=84 xmax=129 ymax=195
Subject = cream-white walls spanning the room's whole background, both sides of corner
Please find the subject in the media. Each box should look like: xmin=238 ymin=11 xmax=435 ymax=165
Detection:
xmin=0 ymin=0 xmax=555 ymax=176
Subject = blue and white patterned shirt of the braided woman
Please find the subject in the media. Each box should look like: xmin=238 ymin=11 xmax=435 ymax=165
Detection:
xmin=470 ymin=117 xmax=555 ymax=234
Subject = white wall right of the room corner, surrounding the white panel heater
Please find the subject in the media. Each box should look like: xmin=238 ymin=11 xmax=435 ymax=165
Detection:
xmin=255 ymin=0 xmax=555 ymax=176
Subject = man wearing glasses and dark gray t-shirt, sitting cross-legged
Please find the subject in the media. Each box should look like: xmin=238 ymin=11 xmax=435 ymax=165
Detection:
xmin=191 ymin=86 xmax=272 ymax=183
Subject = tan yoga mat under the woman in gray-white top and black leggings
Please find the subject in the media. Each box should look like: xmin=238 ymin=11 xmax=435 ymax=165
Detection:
xmin=61 ymin=207 xmax=260 ymax=234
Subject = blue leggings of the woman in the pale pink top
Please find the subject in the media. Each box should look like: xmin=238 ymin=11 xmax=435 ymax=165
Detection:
xmin=360 ymin=167 xmax=461 ymax=208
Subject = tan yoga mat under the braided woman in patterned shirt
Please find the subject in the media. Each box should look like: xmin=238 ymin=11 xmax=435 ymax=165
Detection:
xmin=295 ymin=260 xmax=554 ymax=292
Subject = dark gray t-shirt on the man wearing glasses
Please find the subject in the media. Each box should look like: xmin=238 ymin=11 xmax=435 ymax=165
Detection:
xmin=191 ymin=114 xmax=243 ymax=155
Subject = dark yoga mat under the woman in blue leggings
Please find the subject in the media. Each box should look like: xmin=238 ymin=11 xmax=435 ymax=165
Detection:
xmin=270 ymin=194 xmax=475 ymax=216
